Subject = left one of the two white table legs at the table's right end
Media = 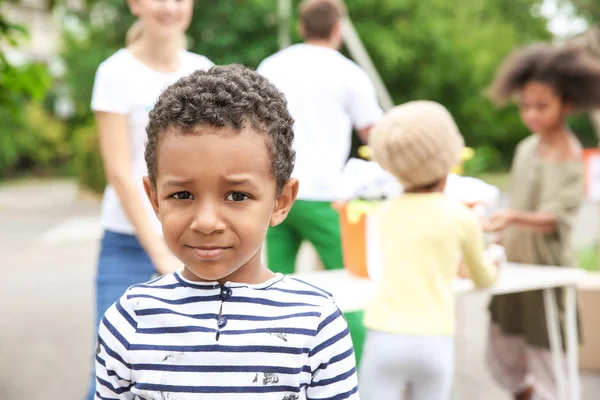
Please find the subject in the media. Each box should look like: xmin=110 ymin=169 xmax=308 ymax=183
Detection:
xmin=544 ymin=288 xmax=567 ymax=400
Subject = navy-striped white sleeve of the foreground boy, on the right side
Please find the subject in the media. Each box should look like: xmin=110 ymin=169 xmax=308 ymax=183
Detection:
xmin=306 ymin=301 xmax=359 ymax=400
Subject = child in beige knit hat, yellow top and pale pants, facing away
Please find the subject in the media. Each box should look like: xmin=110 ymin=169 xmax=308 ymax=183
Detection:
xmin=359 ymin=101 xmax=497 ymax=400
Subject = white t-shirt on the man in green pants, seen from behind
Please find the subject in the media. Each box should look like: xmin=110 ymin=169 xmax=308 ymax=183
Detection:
xmin=257 ymin=44 xmax=383 ymax=201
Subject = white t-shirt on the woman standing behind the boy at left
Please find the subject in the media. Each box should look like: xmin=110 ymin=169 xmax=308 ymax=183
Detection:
xmin=92 ymin=49 xmax=213 ymax=235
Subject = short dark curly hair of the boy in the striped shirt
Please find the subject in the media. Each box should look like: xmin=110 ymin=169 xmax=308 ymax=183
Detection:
xmin=144 ymin=65 xmax=295 ymax=192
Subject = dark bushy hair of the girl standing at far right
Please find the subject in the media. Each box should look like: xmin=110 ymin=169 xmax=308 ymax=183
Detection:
xmin=486 ymin=43 xmax=600 ymax=110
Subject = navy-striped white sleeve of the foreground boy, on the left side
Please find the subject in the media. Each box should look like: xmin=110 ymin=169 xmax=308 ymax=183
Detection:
xmin=96 ymin=293 xmax=137 ymax=400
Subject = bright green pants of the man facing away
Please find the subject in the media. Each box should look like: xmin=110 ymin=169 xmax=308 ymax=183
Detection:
xmin=267 ymin=200 xmax=366 ymax=366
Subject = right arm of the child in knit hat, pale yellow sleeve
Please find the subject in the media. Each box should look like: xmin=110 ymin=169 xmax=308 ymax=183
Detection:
xmin=461 ymin=210 xmax=498 ymax=287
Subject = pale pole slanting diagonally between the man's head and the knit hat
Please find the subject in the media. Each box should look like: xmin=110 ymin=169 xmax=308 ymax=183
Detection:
xmin=342 ymin=17 xmax=394 ymax=110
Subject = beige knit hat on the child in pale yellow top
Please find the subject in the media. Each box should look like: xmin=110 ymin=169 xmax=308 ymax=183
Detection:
xmin=369 ymin=101 xmax=464 ymax=189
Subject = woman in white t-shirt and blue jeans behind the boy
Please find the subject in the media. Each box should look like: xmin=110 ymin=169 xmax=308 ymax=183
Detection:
xmin=88 ymin=0 xmax=213 ymax=399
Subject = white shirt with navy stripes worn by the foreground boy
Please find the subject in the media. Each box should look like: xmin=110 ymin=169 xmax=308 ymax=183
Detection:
xmin=96 ymin=272 xmax=359 ymax=400
